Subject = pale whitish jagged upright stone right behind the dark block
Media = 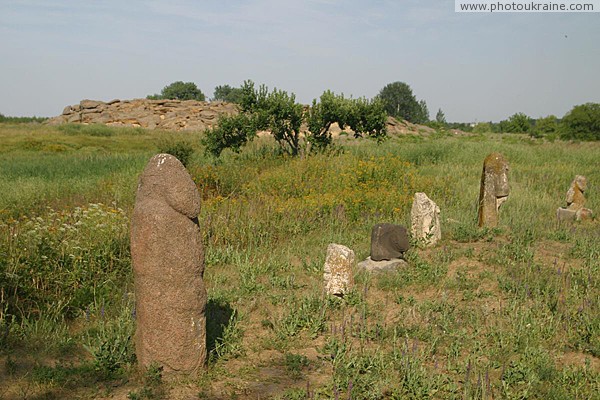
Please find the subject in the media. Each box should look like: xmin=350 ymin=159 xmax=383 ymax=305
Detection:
xmin=410 ymin=192 xmax=442 ymax=246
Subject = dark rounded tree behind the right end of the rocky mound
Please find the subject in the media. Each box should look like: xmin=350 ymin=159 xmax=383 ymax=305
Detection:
xmin=378 ymin=82 xmax=429 ymax=124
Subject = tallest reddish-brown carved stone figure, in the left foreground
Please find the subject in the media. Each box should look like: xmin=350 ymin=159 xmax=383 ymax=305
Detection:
xmin=131 ymin=154 xmax=206 ymax=376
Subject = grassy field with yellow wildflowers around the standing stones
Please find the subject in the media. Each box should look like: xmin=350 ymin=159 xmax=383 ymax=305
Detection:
xmin=0 ymin=124 xmax=600 ymax=400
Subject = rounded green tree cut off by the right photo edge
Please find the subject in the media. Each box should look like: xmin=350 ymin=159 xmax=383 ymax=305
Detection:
xmin=561 ymin=103 xmax=600 ymax=140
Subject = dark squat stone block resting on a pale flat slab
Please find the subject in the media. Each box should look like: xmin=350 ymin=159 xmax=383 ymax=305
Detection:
xmin=371 ymin=224 xmax=410 ymax=261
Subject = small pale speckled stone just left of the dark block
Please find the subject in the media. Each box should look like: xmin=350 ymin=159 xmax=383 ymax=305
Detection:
xmin=323 ymin=243 xmax=355 ymax=296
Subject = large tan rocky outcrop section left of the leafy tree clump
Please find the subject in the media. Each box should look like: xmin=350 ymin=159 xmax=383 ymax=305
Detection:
xmin=48 ymin=99 xmax=238 ymax=131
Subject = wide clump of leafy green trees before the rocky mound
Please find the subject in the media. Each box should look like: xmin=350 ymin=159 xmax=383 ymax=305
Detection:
xmin=203 ymin=81 xmax=387 ymax=156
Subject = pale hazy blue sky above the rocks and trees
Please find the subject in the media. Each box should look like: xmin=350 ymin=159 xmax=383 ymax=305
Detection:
xmin=0 ymin=0 xmax=600 ymax=122
